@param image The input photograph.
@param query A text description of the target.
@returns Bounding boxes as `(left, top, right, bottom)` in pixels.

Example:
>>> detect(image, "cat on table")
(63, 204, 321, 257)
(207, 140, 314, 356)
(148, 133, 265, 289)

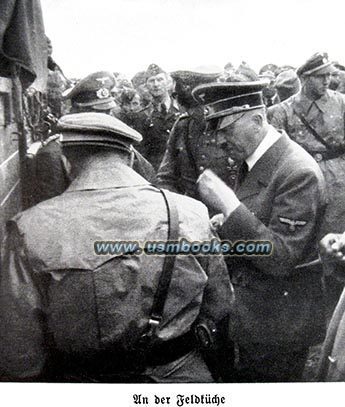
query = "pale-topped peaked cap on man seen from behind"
(58, 112, 142, 151)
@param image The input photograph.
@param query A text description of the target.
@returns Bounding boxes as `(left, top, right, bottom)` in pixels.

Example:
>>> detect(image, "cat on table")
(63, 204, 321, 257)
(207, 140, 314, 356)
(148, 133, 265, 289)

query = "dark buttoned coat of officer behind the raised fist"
(157, 108, 238, 199)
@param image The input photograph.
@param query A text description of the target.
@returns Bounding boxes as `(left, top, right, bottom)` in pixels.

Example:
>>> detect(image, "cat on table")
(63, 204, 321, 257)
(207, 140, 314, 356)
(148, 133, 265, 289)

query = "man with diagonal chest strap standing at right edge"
(268, 53, 345, 313)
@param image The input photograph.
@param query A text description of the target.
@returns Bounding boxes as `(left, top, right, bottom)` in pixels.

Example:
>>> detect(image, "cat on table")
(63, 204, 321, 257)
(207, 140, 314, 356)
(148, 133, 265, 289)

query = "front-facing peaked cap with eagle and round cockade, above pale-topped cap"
(62, 71, 116, 110)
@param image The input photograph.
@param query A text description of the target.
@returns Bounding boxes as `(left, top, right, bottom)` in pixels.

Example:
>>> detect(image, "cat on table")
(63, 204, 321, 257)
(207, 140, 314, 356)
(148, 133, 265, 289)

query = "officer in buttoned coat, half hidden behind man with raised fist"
(157, 71, 236, 198)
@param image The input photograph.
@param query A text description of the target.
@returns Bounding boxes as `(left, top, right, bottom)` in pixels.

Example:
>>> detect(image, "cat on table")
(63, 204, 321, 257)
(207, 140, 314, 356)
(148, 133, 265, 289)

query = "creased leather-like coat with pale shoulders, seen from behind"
(0, 162, 232, 378)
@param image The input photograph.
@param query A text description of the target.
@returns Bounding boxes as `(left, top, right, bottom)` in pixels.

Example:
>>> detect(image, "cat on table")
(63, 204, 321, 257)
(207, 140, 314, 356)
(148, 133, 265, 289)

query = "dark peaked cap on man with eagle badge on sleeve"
(193, 80, 267, 121)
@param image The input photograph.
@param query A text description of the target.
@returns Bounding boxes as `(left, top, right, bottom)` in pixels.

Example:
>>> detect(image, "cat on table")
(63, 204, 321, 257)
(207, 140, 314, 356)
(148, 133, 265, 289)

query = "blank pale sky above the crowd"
(41, 0, 345, 78)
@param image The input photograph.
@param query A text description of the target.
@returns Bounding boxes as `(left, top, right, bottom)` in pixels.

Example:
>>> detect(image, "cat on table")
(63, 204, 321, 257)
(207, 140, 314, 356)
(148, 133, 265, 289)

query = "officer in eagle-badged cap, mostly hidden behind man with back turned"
(35, 71, 155, 203)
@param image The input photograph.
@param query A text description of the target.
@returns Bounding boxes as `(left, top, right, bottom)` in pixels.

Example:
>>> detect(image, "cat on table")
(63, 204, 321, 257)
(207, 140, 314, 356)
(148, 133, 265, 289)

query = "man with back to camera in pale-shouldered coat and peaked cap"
(0, 113, 232, 382)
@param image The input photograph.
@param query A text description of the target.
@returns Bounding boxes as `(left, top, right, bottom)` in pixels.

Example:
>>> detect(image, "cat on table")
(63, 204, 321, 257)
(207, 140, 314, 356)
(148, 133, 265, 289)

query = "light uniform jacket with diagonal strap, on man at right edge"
(267, 90, 345, 235)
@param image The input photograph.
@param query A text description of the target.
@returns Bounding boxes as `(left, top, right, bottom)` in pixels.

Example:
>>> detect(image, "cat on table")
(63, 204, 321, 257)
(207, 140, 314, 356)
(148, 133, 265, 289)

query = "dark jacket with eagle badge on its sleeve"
(220, 129, 325, 346)
